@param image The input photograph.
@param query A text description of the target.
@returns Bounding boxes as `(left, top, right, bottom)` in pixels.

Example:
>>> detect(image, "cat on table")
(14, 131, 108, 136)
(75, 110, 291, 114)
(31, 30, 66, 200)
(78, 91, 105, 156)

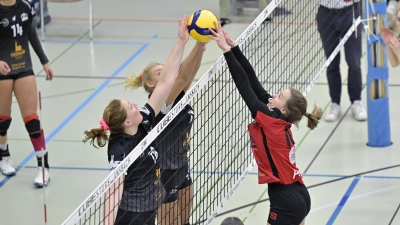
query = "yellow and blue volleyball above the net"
(187, 10, 218, 42)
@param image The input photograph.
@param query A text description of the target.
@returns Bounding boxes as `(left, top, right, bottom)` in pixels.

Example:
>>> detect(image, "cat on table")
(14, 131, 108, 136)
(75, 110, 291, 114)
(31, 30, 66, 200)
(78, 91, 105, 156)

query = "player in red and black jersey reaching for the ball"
(209, 23, 322, 225)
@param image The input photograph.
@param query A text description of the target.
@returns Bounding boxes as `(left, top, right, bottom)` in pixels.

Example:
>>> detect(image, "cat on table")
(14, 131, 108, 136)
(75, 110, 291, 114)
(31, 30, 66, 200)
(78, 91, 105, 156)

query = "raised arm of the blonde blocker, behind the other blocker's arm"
(166, 42, 205, 105)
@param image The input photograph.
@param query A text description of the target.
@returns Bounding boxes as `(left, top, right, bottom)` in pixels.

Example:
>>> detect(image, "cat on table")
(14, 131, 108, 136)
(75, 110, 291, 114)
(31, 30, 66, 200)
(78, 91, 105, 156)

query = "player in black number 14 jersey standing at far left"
(0, 0, 53, 187)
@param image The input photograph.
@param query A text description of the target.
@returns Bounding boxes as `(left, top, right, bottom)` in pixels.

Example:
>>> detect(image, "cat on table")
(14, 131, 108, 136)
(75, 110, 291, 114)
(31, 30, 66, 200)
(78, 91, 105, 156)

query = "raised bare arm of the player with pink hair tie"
(148, 14, 189, 115)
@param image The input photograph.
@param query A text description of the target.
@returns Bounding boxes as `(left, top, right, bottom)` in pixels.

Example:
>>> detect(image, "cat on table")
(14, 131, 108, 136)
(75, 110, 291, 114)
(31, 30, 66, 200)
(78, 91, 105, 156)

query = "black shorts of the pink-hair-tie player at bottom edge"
(114, 209, 156, 225)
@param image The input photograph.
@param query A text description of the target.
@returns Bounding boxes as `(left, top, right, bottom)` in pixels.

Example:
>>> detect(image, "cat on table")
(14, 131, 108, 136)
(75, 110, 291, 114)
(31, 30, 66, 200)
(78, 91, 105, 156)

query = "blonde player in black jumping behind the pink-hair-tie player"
(125, 42, 205, 225)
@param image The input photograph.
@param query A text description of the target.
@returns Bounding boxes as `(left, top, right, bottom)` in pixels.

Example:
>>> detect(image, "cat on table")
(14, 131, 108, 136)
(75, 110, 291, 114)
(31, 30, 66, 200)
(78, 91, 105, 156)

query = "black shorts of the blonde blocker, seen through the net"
(161, 163, 192, 203)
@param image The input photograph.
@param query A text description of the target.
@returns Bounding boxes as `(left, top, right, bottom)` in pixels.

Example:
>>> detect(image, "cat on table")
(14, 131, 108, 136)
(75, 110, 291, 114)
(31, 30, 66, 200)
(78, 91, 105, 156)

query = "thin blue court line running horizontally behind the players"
(12, 166, 400, 179)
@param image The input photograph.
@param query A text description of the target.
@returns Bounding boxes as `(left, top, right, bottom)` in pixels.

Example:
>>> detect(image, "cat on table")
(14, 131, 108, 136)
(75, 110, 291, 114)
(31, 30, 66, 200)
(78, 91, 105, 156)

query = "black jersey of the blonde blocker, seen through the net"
(153, 91, 194, 170)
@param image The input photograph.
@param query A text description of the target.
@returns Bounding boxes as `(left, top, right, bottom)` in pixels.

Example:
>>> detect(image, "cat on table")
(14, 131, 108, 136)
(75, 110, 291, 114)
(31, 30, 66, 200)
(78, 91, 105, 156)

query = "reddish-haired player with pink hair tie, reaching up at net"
(83, 15, 189, 225)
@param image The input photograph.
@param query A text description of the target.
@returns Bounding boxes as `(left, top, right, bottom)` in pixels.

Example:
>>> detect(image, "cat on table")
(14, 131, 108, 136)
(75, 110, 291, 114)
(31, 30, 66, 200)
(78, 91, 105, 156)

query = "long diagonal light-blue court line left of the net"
(0, 43, 149, 188)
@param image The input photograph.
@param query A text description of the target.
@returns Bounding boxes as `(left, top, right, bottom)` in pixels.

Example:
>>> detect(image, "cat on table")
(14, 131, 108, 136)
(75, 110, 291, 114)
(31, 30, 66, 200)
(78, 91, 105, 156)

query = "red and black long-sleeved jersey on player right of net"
(224, 46, 303, 184)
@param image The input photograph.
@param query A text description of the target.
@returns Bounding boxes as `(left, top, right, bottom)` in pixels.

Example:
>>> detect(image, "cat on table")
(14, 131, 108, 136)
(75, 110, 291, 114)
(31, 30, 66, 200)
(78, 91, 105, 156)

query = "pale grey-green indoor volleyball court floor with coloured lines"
(0, 0, 400, 225)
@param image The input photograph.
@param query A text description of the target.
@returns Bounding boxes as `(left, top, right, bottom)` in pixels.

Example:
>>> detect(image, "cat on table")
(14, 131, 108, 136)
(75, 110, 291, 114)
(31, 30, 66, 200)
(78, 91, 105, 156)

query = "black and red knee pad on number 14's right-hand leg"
(24, 113, 47, 157)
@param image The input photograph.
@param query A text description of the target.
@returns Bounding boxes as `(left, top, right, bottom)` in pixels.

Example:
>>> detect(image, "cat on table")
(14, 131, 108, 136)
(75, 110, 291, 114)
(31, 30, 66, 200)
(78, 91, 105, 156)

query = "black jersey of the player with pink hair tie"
(108, 104, 165, 212)
